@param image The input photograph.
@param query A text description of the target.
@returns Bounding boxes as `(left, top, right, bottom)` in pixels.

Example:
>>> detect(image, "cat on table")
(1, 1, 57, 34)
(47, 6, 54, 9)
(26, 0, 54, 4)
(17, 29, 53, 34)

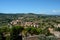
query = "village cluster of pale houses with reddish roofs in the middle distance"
(10, 20, 39, 28)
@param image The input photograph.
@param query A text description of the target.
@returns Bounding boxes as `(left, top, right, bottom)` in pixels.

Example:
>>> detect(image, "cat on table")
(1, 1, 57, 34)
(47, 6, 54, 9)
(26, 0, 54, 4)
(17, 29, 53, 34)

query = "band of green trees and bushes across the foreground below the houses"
(0, 26, 52, 40)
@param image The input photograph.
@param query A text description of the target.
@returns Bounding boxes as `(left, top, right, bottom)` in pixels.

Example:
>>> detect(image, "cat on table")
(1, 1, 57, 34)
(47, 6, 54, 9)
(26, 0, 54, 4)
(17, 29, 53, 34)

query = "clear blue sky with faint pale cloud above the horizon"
(0, 0, 60, 14)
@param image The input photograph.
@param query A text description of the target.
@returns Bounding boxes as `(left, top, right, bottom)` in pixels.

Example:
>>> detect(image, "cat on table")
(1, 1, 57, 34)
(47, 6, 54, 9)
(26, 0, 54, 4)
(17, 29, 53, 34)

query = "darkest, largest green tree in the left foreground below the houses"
(10, 26, 24, 40)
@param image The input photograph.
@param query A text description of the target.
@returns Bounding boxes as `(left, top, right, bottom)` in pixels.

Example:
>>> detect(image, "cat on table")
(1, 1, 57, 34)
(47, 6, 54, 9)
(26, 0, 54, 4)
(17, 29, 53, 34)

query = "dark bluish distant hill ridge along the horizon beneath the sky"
(0, 13, 60, 16)
